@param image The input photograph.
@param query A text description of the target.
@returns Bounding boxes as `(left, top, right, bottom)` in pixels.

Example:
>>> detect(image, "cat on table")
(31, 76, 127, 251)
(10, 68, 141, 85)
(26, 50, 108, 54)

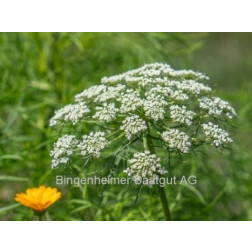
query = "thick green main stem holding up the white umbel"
(144, 124, 171, 221)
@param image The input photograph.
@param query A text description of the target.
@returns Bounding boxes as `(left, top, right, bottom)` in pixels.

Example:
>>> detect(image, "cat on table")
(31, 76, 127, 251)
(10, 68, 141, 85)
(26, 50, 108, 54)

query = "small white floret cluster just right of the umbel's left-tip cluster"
(93, 102, 119, 122)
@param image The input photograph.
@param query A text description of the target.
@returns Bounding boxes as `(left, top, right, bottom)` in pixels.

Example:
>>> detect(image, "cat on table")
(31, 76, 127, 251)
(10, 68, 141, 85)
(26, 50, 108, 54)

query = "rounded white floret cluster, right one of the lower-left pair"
(77, 132, 108, 158)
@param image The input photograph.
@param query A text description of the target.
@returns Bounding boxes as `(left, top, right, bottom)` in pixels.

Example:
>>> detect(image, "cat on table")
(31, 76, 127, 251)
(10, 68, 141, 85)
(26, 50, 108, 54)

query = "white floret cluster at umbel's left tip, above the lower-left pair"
(50, 102, 90, 126)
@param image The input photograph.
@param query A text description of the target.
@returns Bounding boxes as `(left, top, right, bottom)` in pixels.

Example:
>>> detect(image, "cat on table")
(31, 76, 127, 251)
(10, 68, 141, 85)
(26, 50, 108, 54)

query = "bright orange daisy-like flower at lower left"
(15, 186, 61, 213)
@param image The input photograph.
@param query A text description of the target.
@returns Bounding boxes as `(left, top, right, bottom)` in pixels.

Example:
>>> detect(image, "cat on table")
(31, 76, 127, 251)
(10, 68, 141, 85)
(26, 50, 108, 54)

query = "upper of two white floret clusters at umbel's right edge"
(199, 97, 237, 119)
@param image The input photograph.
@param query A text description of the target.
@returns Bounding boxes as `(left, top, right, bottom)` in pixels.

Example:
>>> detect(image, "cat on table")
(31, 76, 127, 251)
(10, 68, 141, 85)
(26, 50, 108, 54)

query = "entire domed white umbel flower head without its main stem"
(50, 63, 236, 173)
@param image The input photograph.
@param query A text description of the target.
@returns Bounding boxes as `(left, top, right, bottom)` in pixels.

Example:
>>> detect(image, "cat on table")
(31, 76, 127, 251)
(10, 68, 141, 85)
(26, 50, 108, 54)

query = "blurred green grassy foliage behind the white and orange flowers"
(0, 33, 252, 220)
